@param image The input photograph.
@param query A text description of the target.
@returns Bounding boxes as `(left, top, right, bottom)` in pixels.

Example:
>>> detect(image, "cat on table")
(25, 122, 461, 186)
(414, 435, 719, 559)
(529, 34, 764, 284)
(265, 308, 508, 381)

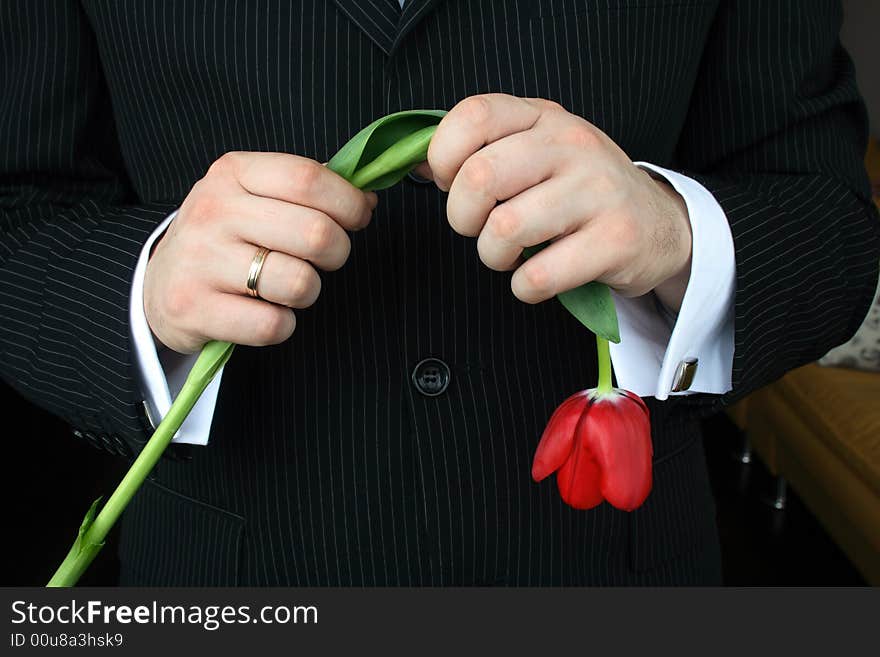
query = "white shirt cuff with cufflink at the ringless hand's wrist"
(611, 162, 736, 400)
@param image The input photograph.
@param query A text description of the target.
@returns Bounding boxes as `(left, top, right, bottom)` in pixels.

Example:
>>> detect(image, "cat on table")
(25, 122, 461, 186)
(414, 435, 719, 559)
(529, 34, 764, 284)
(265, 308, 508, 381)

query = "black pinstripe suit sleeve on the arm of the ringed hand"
(0, 0, 177, 455)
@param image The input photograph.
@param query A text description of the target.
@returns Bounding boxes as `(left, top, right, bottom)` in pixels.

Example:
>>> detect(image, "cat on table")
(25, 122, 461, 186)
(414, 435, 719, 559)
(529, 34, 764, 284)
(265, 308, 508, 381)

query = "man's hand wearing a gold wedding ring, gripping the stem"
(144, 152, 376, 353)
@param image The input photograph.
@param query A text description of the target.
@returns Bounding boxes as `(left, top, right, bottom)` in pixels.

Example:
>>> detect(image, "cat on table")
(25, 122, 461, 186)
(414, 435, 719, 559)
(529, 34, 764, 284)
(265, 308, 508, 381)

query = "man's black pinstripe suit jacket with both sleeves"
(0, 0, 878, 585)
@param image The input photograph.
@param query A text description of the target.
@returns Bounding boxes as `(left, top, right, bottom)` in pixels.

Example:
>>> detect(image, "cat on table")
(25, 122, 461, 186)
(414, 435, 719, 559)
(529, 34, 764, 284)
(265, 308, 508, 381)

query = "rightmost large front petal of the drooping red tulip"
(583, 393, 653, 511)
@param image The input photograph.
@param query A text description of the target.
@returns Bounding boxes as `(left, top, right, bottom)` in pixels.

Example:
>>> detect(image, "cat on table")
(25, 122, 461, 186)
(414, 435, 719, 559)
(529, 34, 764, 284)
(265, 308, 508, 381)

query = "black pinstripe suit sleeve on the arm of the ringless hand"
(669, 0, 880, 409)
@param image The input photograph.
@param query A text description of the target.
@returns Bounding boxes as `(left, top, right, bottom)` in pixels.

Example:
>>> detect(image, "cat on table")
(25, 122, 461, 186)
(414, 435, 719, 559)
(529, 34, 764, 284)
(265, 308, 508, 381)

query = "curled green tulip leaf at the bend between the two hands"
(327, 110, 446, 183)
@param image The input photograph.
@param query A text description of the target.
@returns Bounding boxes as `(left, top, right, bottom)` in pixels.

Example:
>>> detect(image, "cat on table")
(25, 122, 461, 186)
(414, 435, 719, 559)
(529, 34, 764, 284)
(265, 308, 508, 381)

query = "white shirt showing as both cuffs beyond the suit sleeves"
(130, 162, 736, 445)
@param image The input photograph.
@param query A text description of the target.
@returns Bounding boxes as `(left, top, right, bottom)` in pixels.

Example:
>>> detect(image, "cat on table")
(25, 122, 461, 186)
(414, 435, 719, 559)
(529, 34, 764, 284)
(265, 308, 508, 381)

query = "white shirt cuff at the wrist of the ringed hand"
(129, 212, 223, 445)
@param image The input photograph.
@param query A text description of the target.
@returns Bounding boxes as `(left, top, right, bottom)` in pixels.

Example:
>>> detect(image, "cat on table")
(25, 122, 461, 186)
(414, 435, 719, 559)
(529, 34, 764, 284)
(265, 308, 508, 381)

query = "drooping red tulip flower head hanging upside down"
(532, 388, 653, 511)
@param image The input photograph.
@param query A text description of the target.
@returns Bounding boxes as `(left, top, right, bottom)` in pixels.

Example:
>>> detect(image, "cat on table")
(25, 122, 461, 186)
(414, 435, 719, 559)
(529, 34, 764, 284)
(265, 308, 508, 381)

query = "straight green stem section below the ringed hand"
(47, 341, 235, 587)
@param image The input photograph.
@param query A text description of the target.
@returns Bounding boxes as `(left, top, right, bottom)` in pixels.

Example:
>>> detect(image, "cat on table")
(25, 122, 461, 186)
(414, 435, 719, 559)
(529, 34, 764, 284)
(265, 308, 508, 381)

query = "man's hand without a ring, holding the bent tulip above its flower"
(419, 94, 691, 310)
